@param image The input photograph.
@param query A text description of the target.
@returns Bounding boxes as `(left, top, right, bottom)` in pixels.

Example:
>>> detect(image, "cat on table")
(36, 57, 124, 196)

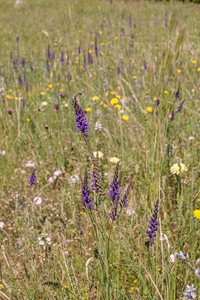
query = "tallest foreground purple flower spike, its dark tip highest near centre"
(72, 97, 89, 136)
